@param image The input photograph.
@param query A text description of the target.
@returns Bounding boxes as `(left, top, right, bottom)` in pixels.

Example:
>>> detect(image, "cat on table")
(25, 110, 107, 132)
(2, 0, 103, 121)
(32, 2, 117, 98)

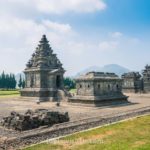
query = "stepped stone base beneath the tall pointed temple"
(20, 88, 57, 101)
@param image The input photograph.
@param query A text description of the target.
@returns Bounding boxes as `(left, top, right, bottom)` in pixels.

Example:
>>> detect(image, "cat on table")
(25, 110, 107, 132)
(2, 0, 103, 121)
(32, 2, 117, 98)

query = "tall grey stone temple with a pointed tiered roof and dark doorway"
(21, 35, 65, 101)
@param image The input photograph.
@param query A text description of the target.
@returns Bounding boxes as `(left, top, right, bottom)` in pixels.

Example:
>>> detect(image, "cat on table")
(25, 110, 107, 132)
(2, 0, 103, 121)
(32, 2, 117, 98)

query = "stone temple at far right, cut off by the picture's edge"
(143, 65, 150, 93)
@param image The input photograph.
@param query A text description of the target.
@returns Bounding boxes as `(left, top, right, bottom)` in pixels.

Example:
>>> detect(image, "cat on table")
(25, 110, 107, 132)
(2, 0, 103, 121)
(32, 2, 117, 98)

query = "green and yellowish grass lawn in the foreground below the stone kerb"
(24, 116, 150, 150)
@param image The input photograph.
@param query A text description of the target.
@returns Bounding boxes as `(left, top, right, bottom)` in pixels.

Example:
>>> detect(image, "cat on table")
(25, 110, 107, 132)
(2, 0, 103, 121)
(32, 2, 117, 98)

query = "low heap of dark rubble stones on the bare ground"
(0, 109, 69, 131)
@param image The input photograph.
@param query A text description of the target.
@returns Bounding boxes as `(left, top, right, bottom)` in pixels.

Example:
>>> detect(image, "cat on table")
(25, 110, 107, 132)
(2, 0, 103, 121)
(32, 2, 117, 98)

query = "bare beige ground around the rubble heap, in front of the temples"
(0, 94, 150, 149)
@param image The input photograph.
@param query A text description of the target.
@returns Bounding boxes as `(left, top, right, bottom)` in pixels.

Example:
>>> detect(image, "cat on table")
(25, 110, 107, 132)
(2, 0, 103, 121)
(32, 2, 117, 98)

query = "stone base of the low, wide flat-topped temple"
(69, 95, 128, 106)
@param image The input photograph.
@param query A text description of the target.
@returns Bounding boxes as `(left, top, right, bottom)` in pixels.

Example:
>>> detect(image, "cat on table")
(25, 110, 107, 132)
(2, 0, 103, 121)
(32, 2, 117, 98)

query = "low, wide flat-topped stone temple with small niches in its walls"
(69, 72, 128, 104)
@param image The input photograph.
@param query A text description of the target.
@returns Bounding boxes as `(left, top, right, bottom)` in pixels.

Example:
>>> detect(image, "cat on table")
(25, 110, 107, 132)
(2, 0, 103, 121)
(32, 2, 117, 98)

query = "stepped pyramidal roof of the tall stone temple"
(26, 35, 63, 69)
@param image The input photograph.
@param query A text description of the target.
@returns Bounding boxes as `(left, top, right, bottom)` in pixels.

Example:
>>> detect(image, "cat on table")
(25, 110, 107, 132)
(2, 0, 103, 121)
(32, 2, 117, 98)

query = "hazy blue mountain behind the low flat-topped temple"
(75, 64, 130, 77)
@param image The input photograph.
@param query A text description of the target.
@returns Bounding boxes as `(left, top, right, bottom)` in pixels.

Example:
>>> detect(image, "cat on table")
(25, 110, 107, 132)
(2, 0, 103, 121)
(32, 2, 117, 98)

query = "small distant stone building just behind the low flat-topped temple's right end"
(122, 72, 143, 93)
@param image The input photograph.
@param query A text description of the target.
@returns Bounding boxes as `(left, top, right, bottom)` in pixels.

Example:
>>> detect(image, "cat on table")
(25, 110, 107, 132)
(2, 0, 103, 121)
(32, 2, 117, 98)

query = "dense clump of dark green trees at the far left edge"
(0, 71, 17, 89)
